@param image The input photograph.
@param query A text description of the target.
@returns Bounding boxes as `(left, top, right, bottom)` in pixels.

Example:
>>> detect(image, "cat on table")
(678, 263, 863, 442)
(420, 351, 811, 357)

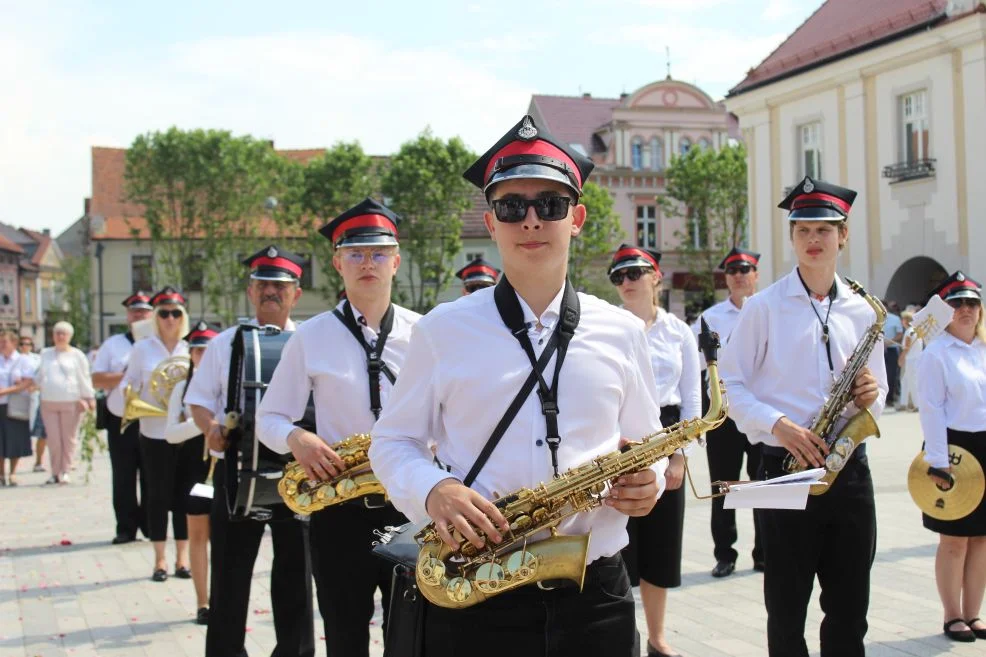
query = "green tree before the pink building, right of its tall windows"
(658, 144, 747, 310)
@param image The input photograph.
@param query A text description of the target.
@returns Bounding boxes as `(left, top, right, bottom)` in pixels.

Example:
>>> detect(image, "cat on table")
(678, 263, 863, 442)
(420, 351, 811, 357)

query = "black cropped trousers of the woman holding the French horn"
(140, 435, 201, 541)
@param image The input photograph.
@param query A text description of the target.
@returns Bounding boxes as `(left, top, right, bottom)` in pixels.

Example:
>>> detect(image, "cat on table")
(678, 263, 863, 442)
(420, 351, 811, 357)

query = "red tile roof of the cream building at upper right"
(729, 0, 947, 96)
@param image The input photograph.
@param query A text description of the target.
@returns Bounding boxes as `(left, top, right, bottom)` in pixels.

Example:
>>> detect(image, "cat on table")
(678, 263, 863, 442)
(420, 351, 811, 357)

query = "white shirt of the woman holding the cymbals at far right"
(917, 333, 986, 468)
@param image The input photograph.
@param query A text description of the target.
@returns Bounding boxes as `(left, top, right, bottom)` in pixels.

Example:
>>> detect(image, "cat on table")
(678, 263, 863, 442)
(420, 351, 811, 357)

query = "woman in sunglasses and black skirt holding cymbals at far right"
(917, 271, 986, 641)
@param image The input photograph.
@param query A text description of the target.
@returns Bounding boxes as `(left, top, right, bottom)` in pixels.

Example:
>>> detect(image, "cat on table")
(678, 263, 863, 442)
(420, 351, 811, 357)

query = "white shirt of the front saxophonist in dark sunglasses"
(370, 287, 667, 562)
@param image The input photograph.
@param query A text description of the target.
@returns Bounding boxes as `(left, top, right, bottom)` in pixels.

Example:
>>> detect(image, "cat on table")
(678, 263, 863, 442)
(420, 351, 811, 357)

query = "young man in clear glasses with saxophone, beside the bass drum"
(257, 198, 420, 657)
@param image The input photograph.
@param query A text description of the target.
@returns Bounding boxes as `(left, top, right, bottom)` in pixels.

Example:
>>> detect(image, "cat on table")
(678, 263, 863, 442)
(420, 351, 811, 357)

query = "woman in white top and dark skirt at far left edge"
(0, 330, 34, 486)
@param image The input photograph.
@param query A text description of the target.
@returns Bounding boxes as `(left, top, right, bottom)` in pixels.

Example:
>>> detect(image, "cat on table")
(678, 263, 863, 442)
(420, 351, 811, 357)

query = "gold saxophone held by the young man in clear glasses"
(277, 433, 387, 516)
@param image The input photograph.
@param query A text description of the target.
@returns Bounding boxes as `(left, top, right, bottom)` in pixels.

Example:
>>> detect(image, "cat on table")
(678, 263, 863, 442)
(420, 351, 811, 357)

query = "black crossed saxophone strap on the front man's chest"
(462, 276, 581, 486)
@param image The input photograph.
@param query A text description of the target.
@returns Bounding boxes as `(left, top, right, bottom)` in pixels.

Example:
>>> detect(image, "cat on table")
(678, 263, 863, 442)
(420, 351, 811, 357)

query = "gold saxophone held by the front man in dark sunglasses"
(414, 320, 726, 609)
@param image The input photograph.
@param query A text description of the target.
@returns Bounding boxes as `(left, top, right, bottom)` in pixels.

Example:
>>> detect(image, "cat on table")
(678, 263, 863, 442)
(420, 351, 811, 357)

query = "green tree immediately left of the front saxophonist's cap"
(381, 129, 476, 312)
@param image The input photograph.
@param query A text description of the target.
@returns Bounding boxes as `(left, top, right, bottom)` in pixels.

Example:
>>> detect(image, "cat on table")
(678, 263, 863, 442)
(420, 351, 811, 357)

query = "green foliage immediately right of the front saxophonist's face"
(568, 182, 625, 301)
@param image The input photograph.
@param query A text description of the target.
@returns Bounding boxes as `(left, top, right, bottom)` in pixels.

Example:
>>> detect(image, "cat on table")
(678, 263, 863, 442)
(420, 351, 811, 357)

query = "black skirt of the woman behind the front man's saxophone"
(623, 406, 685, 589)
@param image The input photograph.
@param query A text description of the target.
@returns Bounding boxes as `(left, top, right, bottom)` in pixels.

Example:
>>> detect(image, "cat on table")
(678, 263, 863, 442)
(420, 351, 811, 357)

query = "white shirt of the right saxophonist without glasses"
(720, 268, 887, 446)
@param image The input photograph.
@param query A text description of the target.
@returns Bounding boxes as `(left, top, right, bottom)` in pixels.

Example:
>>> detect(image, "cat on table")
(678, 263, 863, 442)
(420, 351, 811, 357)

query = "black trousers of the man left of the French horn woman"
(106, 411, 150, 537)
